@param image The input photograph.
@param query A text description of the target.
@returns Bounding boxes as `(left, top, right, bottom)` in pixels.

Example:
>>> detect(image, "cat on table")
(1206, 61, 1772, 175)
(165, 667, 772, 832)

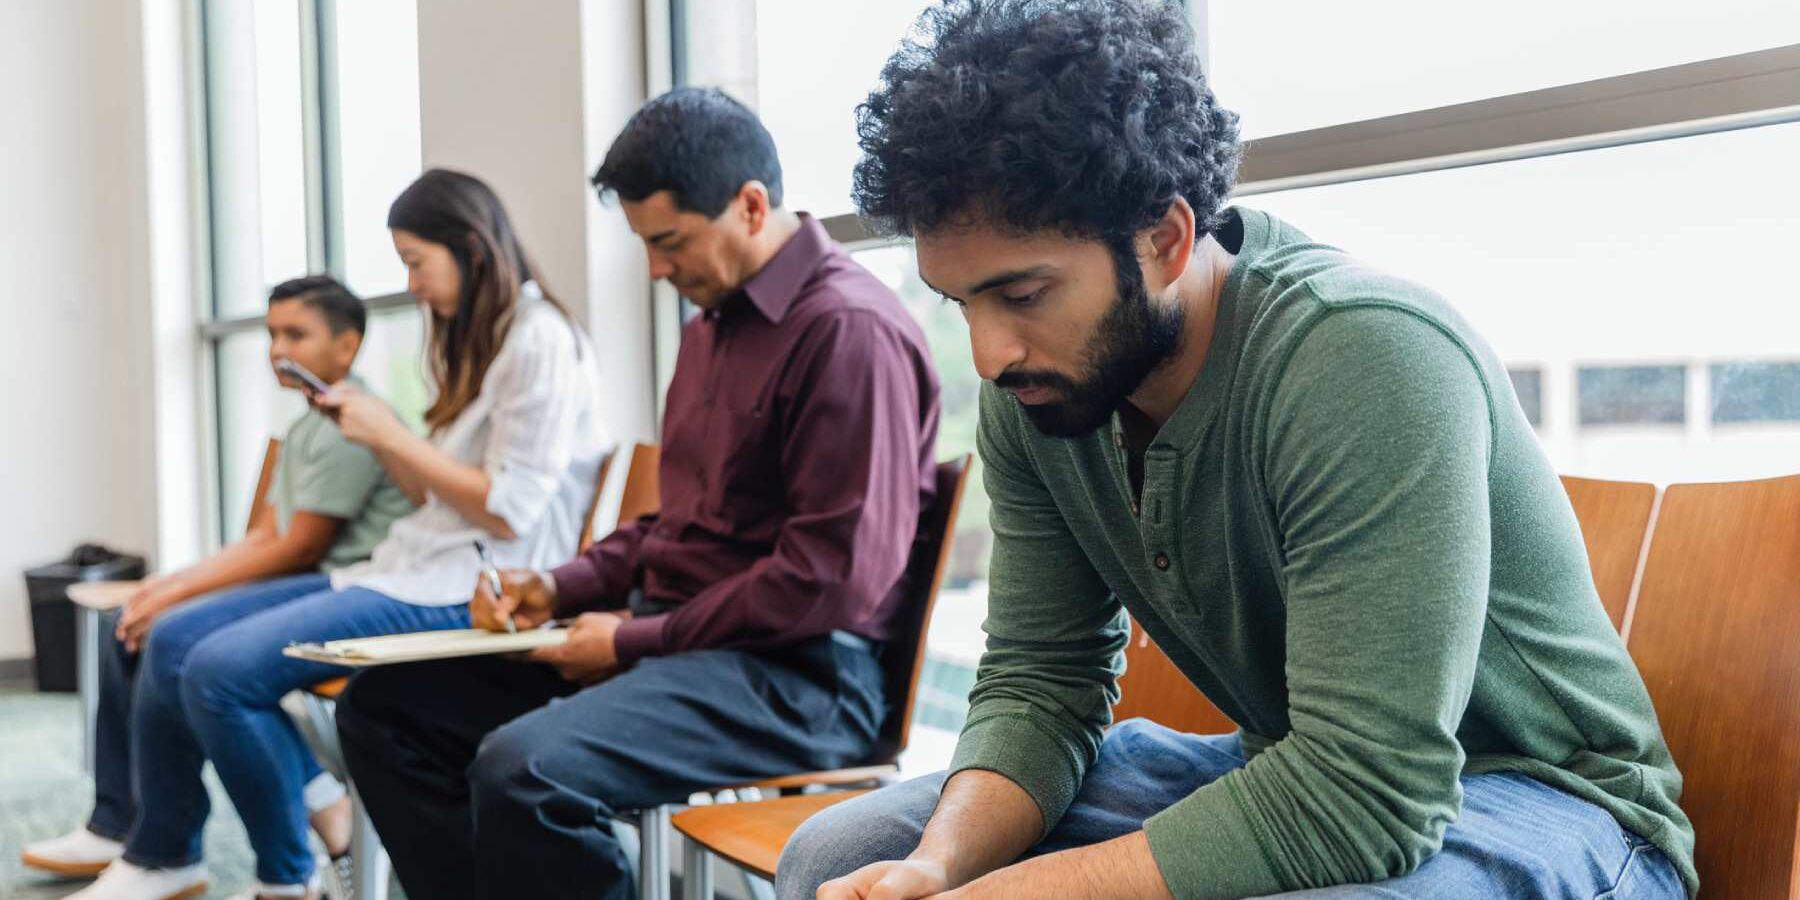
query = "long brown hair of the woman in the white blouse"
(387, 169, 574, 434)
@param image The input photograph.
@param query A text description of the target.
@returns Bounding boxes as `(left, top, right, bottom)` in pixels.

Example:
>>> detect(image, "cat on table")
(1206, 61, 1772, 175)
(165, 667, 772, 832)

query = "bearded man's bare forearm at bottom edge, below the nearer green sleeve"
(954, 828, 1174, 900)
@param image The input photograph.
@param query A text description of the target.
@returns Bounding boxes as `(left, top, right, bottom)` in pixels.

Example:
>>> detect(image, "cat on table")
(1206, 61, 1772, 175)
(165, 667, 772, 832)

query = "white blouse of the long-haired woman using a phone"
(331, 281, 607, 607)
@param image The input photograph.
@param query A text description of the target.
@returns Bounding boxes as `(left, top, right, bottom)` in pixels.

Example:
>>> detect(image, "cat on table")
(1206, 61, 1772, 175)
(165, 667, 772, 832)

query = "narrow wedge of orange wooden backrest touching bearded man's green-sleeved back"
(1562, 475, 1656, 632)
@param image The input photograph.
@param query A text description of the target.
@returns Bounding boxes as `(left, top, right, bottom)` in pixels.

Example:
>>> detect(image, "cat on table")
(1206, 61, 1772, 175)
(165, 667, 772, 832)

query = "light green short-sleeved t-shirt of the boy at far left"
(270, 378, 414, 572)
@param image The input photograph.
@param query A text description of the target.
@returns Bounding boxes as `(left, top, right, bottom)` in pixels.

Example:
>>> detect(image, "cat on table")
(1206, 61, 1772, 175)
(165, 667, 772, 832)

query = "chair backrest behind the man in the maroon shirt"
(869, 454, 970, 765)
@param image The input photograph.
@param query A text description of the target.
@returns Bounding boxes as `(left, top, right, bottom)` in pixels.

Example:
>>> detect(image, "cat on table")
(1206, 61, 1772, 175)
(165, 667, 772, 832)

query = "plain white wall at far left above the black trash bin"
(0, 0, 157, 659)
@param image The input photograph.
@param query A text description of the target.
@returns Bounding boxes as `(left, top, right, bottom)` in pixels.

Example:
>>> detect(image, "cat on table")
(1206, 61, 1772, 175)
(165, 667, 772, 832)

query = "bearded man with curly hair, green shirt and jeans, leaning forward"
(778, 0, 1697, 900)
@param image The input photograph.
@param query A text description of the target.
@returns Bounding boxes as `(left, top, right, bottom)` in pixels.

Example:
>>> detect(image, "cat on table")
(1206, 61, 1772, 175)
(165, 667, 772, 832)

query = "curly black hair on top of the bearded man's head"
(853, 0, 1238, 247)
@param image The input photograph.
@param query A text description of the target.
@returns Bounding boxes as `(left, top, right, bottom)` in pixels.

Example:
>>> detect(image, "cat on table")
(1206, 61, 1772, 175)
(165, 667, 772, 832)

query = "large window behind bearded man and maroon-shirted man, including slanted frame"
(670, 0, 1800, 748)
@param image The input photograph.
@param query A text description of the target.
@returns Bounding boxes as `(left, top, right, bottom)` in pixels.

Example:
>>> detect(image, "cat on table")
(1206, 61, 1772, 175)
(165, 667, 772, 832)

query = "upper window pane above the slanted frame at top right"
(1204, 0, 1800, 137)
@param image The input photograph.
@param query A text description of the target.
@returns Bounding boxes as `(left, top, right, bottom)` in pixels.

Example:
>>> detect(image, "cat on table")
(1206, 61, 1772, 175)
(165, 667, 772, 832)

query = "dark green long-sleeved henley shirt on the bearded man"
(952, 209, 1696, 898)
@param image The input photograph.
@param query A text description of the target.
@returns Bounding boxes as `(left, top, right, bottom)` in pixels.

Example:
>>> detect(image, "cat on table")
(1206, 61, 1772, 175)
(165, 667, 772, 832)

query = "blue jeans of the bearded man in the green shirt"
(776, 718, 1687, 900)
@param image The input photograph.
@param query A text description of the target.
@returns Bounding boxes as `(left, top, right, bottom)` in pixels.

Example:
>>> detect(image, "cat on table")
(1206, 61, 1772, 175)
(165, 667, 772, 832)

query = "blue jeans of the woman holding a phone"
(124, 574, 468, 884)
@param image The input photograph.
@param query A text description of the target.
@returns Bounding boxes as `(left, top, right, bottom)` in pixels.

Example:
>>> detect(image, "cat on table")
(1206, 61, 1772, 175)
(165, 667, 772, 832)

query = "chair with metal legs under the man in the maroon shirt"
(637, 454, 970, 900)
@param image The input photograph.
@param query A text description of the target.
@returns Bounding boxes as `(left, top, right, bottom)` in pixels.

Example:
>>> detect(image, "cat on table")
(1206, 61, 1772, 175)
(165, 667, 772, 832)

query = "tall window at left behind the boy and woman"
(196, 0, 427, 540)
